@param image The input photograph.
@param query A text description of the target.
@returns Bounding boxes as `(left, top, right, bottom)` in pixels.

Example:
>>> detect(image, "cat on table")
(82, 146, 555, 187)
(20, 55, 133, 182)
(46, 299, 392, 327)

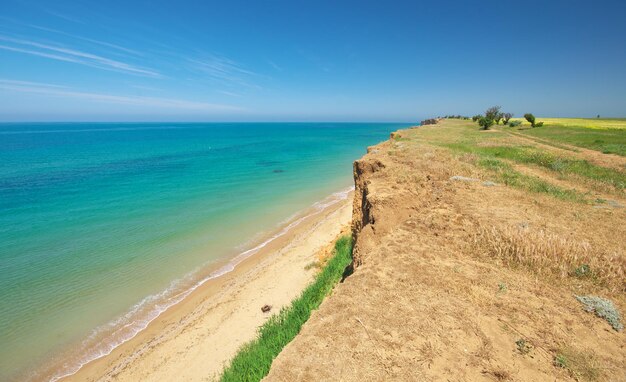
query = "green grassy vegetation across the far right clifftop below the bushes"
(410, 117, 626, 198)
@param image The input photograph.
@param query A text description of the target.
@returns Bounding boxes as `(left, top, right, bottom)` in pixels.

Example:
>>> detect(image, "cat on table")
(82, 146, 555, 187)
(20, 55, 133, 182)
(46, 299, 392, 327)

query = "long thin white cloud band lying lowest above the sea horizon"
(0, 79, 242, 112)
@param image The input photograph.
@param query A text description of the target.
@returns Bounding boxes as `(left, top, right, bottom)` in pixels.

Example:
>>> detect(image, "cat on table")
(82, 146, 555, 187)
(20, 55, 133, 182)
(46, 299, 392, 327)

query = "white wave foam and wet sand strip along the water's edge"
(45, 187, 354, 382)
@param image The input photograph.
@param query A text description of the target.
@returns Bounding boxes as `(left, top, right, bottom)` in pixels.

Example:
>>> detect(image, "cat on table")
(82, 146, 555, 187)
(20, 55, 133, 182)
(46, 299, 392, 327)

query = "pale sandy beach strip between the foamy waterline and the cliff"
(56, 192, 353, 381)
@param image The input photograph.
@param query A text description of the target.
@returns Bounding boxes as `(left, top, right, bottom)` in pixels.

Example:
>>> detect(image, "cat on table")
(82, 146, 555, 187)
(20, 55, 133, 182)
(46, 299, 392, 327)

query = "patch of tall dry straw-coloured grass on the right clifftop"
(473, 227, 626, 292)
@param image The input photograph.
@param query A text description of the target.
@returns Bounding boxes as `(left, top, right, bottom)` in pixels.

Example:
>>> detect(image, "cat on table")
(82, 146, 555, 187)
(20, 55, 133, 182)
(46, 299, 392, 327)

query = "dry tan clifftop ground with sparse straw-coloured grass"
(266, 124, 626, 381)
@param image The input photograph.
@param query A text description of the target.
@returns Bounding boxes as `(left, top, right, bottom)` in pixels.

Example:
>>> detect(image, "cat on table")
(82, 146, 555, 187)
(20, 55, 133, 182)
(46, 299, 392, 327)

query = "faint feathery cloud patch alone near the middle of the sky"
(187, 55, 259, 88)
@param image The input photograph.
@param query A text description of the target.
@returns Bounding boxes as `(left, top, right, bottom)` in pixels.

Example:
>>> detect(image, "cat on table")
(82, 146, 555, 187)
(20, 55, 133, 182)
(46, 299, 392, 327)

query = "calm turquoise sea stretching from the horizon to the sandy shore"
(0, 123, 406, 380)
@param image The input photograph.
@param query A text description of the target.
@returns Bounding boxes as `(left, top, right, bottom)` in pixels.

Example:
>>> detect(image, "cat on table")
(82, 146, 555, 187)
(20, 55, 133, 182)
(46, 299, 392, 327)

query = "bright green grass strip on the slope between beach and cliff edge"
(221, 236, 352, 382)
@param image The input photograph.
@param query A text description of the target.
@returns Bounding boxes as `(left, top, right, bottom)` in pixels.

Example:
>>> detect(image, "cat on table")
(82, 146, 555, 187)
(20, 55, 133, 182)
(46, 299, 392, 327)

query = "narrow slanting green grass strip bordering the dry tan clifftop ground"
(477, 158, 586, 203)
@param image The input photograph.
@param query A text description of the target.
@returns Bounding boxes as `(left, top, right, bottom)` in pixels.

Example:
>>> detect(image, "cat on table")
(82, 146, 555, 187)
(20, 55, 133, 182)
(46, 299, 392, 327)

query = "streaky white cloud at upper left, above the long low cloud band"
(0, 35, 162, 78)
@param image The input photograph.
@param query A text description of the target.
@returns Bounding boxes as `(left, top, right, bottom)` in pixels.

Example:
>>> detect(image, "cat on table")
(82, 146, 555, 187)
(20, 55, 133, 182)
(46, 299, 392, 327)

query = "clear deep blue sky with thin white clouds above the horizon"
(0, 0, 626, 122)
